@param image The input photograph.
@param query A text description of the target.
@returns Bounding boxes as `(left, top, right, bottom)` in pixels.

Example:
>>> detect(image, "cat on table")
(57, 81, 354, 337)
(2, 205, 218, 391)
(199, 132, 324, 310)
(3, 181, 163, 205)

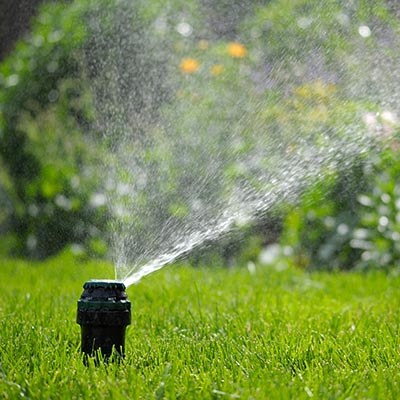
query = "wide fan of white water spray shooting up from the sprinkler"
(82, 0, 400, 287)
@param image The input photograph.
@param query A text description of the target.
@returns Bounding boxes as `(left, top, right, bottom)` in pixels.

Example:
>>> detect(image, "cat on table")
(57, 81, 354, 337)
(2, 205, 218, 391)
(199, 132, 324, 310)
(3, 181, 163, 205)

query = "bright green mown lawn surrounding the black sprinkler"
(0, 257, 400, 399)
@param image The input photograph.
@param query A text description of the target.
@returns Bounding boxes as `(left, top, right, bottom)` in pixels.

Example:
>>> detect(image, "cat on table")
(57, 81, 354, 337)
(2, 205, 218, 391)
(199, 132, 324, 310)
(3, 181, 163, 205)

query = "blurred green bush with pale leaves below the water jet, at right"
(280, 132, 400, 270)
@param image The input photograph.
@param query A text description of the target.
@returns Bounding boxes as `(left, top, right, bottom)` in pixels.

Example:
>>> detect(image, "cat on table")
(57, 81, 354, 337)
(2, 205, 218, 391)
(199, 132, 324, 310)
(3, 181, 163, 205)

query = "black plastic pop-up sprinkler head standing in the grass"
(76, 280, 131, 360)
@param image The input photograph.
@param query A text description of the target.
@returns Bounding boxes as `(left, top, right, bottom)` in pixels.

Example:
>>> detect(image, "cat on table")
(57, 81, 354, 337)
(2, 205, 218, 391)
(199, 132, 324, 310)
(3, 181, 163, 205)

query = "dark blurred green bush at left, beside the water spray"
(0, 0, 178, 258)
